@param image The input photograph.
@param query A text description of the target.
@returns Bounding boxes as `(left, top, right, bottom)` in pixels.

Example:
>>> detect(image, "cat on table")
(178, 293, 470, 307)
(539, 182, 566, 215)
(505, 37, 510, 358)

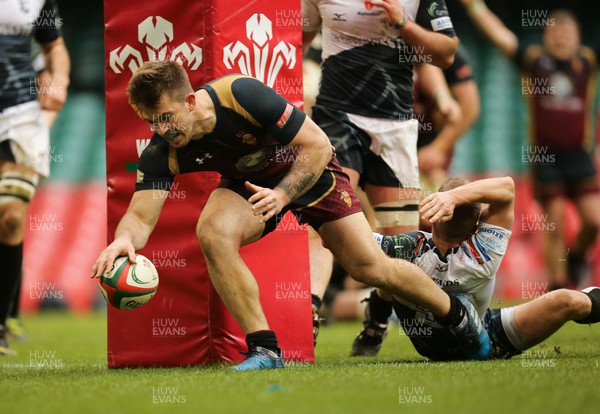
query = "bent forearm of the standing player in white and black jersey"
(399, 20, 458, 68)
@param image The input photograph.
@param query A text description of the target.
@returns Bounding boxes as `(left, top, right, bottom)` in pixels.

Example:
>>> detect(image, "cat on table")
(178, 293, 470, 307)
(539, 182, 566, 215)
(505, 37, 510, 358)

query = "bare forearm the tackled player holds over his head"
(450, 177, 515, 206)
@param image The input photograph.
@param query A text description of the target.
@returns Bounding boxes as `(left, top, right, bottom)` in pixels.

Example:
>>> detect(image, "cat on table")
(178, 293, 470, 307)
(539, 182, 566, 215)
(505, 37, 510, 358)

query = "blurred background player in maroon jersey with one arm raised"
(461, 0, 600, 290)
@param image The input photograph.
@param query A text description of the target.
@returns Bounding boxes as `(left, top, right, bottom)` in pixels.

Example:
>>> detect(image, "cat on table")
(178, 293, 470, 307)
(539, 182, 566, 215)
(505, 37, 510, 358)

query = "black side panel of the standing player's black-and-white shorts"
(312, 105, 402, 188)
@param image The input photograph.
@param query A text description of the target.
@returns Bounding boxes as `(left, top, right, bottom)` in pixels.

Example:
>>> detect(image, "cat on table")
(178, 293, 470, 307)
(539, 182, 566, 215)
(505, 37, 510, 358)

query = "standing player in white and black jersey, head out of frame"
(302, 0, 458, 342)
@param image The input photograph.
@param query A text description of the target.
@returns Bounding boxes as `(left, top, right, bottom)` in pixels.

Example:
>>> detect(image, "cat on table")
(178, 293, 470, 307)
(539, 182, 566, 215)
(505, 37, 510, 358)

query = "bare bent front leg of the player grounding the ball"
(196, 188, 269, 334)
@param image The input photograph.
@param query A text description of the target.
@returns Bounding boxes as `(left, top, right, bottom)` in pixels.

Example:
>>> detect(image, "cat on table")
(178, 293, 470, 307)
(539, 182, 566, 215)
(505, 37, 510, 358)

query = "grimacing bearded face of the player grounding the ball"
(144, 96, 193, 148)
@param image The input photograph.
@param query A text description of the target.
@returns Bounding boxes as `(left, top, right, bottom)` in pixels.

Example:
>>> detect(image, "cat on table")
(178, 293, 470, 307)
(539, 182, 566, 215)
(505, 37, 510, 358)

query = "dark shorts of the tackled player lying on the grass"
(394, 301, 522, 361)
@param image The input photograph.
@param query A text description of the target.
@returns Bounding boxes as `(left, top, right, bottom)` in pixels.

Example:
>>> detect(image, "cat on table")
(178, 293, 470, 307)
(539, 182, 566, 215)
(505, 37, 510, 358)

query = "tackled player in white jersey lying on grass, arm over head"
(352, 177, 600, 361)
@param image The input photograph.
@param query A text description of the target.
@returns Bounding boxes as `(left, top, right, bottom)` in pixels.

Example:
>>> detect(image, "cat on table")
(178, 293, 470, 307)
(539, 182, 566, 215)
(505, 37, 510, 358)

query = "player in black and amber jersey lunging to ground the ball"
(92, 62, 491, 370)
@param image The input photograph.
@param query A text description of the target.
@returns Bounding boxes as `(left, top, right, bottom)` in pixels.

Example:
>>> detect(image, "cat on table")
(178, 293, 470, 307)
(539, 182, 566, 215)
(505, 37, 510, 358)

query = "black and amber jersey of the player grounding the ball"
(136, 75, 306, 191)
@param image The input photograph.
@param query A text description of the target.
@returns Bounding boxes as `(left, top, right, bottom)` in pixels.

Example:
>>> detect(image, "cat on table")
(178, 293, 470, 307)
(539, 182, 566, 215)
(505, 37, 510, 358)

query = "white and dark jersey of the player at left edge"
(0, 0, 62, 111)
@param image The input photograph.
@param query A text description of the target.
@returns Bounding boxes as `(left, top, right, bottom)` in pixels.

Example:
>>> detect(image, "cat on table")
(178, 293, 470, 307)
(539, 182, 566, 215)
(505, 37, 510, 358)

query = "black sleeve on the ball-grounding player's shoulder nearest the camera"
(231, 77, 306, 145)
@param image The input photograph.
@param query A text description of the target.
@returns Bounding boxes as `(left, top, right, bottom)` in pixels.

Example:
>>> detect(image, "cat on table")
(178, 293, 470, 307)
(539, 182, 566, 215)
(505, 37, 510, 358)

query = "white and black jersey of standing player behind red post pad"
(302, 0, 455, 119)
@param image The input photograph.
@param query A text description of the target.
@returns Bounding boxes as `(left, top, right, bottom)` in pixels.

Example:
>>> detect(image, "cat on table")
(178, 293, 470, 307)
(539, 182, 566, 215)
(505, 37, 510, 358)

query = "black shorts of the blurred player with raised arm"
(525, 148, 598, 203)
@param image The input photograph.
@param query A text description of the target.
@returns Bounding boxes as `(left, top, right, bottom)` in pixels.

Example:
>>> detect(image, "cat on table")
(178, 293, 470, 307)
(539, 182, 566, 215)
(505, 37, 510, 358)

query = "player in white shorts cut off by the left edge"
(0, 0, 70, 355)
